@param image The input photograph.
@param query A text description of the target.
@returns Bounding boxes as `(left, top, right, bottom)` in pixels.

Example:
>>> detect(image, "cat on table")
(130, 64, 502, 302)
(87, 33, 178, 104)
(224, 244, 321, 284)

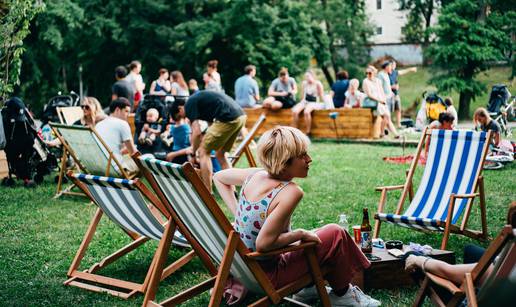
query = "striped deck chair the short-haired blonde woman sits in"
(135, 157, 330, 306)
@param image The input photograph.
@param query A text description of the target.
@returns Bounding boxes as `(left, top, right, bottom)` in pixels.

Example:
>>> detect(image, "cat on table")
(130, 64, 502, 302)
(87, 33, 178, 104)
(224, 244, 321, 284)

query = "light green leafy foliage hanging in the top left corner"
(0, 0, 44, 101)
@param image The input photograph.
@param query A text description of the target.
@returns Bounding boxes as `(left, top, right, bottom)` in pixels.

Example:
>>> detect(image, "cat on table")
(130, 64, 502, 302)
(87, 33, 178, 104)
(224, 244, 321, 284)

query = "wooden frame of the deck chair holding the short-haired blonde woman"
(133, 153, 330, 307)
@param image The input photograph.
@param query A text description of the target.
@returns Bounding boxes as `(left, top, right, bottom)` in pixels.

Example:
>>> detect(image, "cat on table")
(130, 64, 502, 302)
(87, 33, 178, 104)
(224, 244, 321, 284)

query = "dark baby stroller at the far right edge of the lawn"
(487, 84, 515, 137)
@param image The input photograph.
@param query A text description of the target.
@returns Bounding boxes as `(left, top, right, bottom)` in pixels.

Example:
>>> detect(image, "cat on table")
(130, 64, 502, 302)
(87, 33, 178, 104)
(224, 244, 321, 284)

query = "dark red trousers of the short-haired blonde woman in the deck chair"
(261, 224, 371, 290)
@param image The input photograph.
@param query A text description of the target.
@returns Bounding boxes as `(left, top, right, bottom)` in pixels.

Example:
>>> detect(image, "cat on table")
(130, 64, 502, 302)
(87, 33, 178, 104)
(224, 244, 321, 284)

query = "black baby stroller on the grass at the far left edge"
(1, 97, 57, 187)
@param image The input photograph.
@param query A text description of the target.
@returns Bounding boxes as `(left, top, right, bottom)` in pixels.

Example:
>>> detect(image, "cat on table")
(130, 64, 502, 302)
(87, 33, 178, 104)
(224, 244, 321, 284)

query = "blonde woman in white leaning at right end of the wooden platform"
(362, 66, 399, 138)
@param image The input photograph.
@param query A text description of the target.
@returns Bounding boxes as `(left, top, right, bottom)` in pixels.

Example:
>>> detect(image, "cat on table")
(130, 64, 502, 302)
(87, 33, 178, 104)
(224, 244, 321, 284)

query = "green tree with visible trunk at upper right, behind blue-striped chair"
(426, 0, 514, 119)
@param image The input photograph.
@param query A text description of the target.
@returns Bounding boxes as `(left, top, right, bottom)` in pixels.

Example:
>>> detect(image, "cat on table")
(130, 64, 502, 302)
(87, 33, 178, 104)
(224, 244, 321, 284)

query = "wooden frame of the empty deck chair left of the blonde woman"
(64, 171, 204, 299)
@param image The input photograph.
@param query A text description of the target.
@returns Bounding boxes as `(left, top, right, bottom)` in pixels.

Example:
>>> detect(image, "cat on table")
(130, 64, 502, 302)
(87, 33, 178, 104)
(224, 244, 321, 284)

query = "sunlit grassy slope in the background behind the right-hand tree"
(399, 67, 516, 116)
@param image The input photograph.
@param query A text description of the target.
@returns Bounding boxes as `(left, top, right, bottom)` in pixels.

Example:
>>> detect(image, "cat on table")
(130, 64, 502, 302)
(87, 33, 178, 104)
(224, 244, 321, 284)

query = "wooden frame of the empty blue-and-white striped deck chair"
(374, 128, 492, 250)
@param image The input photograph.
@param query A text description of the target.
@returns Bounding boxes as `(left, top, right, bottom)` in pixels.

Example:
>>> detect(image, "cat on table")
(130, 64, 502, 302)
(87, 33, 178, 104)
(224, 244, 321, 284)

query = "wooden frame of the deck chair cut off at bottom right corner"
(412, 225, 515, 307)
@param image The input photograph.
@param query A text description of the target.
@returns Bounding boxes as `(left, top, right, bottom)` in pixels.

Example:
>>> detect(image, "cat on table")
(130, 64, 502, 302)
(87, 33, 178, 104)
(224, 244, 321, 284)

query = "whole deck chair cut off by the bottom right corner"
(413, 225, 516, 307)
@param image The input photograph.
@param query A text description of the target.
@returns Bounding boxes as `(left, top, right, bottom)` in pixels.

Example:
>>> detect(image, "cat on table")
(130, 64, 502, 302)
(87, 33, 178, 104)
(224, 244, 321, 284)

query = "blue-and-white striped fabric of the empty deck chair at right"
(376, 130, 487, 231)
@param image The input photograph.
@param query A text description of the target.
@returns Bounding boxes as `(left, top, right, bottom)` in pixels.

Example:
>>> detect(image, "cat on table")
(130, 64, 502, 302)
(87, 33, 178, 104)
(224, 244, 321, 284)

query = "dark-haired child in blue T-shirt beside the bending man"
(166, 99, 193, 164)
